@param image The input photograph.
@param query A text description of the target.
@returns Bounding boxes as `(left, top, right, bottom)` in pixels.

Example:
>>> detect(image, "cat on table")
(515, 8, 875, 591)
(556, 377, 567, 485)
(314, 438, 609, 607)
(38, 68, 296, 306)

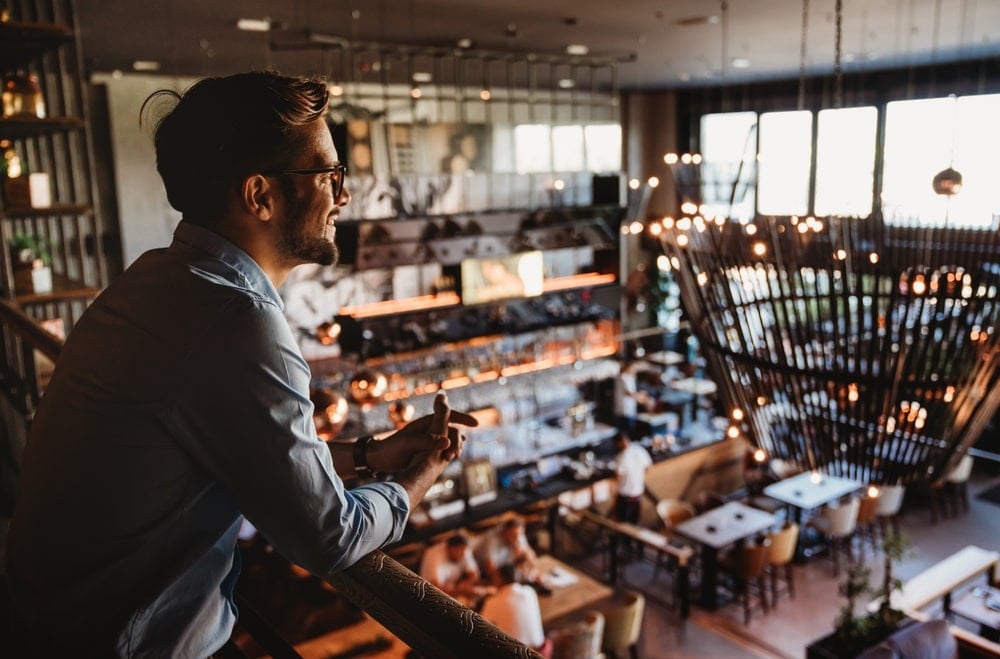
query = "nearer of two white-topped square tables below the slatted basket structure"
(674, 501, 779, 610)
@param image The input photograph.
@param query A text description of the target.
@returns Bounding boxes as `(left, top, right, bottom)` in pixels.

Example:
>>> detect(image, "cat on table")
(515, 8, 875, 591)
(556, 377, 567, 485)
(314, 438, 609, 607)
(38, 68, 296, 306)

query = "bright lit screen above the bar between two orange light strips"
(461, 251, 544, 304)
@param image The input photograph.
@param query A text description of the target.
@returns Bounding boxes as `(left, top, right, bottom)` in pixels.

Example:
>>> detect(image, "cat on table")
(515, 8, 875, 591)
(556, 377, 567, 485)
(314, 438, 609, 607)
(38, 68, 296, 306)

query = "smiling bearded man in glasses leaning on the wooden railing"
(7, 72, 475, 657)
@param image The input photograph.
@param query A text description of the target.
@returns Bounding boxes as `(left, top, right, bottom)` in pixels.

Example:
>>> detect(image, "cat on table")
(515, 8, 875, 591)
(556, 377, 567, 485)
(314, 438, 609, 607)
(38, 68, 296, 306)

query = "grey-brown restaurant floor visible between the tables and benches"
(297, 470, 1000, 659)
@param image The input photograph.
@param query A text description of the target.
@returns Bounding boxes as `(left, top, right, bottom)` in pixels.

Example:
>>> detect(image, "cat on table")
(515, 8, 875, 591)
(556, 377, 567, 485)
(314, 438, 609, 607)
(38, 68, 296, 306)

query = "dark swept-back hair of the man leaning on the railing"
(141, 71, 329, 223)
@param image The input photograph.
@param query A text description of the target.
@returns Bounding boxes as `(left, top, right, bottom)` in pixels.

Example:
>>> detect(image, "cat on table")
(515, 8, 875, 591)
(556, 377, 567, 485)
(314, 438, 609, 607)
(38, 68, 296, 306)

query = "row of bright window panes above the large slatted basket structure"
(700, 94, 1000, 228)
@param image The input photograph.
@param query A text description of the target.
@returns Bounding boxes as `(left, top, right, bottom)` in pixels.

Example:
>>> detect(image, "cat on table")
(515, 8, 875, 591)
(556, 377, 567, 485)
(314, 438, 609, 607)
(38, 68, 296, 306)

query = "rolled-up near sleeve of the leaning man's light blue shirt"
(169, 296, 409, 574)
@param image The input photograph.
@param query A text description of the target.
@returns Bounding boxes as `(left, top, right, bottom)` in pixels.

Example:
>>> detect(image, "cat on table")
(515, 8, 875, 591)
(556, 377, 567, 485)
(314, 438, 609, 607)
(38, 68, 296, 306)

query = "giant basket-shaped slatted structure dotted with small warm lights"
(655, 206, 1000, 484)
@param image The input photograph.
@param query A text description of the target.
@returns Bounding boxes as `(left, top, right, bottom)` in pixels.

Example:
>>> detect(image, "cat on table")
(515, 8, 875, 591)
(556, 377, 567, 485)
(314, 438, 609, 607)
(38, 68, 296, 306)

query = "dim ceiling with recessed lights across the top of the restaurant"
(77, 0, 1000, 89)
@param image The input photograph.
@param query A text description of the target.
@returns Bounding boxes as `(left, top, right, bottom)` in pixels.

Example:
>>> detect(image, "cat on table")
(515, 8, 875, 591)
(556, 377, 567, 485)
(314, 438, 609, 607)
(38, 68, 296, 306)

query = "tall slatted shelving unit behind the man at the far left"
(0, 0, 107, 332)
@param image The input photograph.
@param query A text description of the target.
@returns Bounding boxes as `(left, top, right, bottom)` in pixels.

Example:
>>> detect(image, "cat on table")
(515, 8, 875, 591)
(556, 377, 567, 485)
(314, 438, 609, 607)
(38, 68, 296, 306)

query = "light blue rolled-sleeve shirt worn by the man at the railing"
(8, 222, 409, 657)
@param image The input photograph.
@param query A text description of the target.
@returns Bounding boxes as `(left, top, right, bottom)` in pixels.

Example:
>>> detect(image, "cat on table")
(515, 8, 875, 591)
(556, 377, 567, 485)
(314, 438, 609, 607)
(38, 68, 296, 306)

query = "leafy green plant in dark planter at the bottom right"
(806, 534, 910, 659)
